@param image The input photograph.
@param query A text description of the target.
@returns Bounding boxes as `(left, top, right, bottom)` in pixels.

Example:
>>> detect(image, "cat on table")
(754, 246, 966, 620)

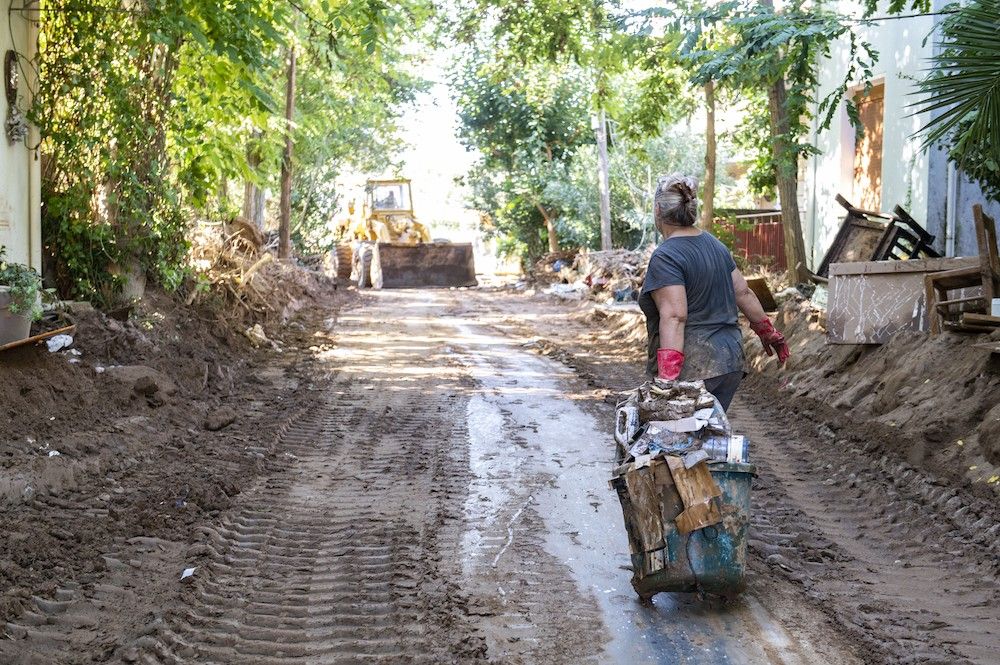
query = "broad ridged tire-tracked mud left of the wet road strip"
(125, 304, 485, 665)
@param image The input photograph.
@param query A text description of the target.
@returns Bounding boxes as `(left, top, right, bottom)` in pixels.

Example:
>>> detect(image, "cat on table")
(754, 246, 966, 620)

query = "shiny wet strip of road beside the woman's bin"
(454, 321, 820, 664)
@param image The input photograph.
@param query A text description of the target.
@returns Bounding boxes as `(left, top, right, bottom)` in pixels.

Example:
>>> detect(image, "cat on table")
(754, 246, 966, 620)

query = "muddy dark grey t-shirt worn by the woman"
(639, 231, 743, 380)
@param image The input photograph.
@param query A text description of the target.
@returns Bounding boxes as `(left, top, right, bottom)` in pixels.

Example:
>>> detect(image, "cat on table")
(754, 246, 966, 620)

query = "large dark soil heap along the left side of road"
(0, 271, 349, 624)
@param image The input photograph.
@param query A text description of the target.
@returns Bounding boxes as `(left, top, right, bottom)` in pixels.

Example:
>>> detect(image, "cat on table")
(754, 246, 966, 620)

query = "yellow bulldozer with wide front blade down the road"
(336, 178, 477, 289)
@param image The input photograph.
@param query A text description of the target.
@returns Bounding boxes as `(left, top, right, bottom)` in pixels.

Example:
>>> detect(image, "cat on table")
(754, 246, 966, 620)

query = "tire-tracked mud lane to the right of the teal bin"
(731, 398, 1000, 664)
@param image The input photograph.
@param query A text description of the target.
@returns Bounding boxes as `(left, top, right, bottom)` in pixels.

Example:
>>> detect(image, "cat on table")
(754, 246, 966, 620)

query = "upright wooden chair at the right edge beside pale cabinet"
(924, 204, 1000, 335)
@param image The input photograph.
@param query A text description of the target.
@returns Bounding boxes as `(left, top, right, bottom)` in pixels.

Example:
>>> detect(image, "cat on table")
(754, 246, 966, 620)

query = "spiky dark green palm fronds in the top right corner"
(915, 0, 1000, 200)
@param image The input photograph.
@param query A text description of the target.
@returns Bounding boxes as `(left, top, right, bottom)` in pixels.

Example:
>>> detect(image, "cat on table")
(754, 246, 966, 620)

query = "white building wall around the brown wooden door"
(803, 1, 934, 268)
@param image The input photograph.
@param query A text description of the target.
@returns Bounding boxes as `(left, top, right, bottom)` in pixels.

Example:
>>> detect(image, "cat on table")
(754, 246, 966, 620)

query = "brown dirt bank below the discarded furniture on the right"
(747, 303, 1000, 489)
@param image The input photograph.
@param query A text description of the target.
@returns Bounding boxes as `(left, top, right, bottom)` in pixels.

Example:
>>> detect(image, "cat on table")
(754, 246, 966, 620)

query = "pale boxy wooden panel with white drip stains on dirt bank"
(827, 257, 979, 344)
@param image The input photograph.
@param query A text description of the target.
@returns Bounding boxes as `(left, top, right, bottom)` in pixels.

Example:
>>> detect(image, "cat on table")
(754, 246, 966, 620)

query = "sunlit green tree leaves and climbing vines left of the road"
(30, 0, 432, 304)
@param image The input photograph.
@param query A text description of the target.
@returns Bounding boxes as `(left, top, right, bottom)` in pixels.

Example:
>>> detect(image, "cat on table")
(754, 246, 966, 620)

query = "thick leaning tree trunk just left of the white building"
(767, 78, 809, 282)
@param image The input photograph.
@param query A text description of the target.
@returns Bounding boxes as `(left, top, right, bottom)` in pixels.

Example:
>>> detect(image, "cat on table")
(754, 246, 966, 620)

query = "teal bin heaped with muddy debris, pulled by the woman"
(611, 380, 754, 599)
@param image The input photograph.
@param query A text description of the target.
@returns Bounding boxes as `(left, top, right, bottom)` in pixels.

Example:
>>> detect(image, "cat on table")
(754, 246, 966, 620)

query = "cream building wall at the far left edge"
(0, 6, 42, 270)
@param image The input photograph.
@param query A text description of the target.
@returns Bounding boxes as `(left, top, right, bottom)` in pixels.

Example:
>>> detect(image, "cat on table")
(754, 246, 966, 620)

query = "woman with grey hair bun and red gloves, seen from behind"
(639, 174, 789, 409)
